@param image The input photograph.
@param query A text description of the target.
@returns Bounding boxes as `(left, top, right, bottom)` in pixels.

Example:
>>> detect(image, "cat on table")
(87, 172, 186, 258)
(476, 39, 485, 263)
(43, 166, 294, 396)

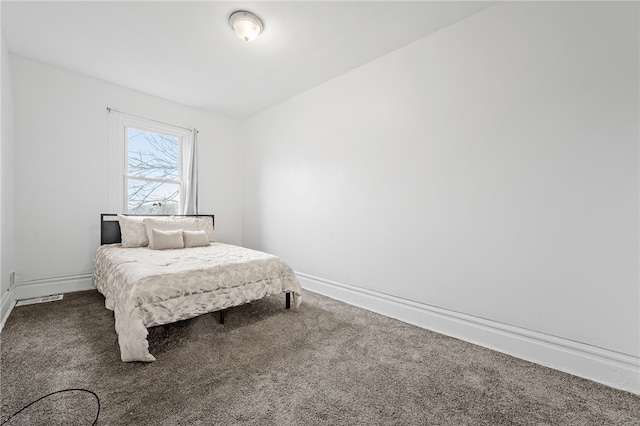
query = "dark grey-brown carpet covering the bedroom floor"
(0, 291, 640, 425)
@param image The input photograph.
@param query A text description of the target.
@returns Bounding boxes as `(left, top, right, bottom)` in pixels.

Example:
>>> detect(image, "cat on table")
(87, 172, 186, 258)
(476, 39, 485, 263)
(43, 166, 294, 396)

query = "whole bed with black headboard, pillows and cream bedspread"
(94, 214, 301, 362)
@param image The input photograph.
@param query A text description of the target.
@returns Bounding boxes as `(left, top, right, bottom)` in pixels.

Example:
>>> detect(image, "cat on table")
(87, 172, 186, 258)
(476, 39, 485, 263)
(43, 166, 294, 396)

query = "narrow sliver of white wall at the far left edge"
(0, 29, 15, 329)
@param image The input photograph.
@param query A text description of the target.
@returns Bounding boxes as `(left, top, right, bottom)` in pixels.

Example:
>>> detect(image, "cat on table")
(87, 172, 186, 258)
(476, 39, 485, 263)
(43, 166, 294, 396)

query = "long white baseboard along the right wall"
(296, 272, 640, 395)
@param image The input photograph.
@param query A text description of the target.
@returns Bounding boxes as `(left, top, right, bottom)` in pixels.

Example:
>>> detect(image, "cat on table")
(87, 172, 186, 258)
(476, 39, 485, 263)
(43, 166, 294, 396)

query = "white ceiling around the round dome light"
(1, 0, 495, 119)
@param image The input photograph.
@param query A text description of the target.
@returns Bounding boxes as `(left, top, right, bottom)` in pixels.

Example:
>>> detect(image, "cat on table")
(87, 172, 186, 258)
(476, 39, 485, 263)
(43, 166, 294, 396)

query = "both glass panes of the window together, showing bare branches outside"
(127, 125, 180, 215)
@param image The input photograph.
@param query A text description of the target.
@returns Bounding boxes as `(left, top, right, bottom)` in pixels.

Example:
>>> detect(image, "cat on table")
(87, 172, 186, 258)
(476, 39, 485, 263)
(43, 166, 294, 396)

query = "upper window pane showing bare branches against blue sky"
(128, 129, 180, 179)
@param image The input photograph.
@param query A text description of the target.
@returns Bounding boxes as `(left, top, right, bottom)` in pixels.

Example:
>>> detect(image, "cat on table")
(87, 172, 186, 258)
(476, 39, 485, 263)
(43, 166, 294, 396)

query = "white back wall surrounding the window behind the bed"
(11, 55, 242, 294)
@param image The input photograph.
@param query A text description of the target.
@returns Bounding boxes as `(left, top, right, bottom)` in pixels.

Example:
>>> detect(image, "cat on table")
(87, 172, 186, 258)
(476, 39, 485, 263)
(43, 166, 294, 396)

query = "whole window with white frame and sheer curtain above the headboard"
(109, 110, 197, 215)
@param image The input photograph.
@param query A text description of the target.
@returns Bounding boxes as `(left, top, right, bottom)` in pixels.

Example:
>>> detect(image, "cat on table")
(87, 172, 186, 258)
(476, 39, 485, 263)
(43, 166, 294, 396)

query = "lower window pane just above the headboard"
(127, 179, 180, 214)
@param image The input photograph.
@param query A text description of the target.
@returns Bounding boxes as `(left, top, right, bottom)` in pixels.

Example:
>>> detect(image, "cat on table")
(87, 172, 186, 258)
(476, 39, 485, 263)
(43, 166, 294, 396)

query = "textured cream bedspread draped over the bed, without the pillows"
(94, 242, 301, 362)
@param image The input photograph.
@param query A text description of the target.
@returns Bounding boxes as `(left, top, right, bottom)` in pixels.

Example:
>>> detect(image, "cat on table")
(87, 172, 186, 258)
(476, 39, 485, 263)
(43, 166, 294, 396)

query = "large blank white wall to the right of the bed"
(243, 2, 640, 392)
